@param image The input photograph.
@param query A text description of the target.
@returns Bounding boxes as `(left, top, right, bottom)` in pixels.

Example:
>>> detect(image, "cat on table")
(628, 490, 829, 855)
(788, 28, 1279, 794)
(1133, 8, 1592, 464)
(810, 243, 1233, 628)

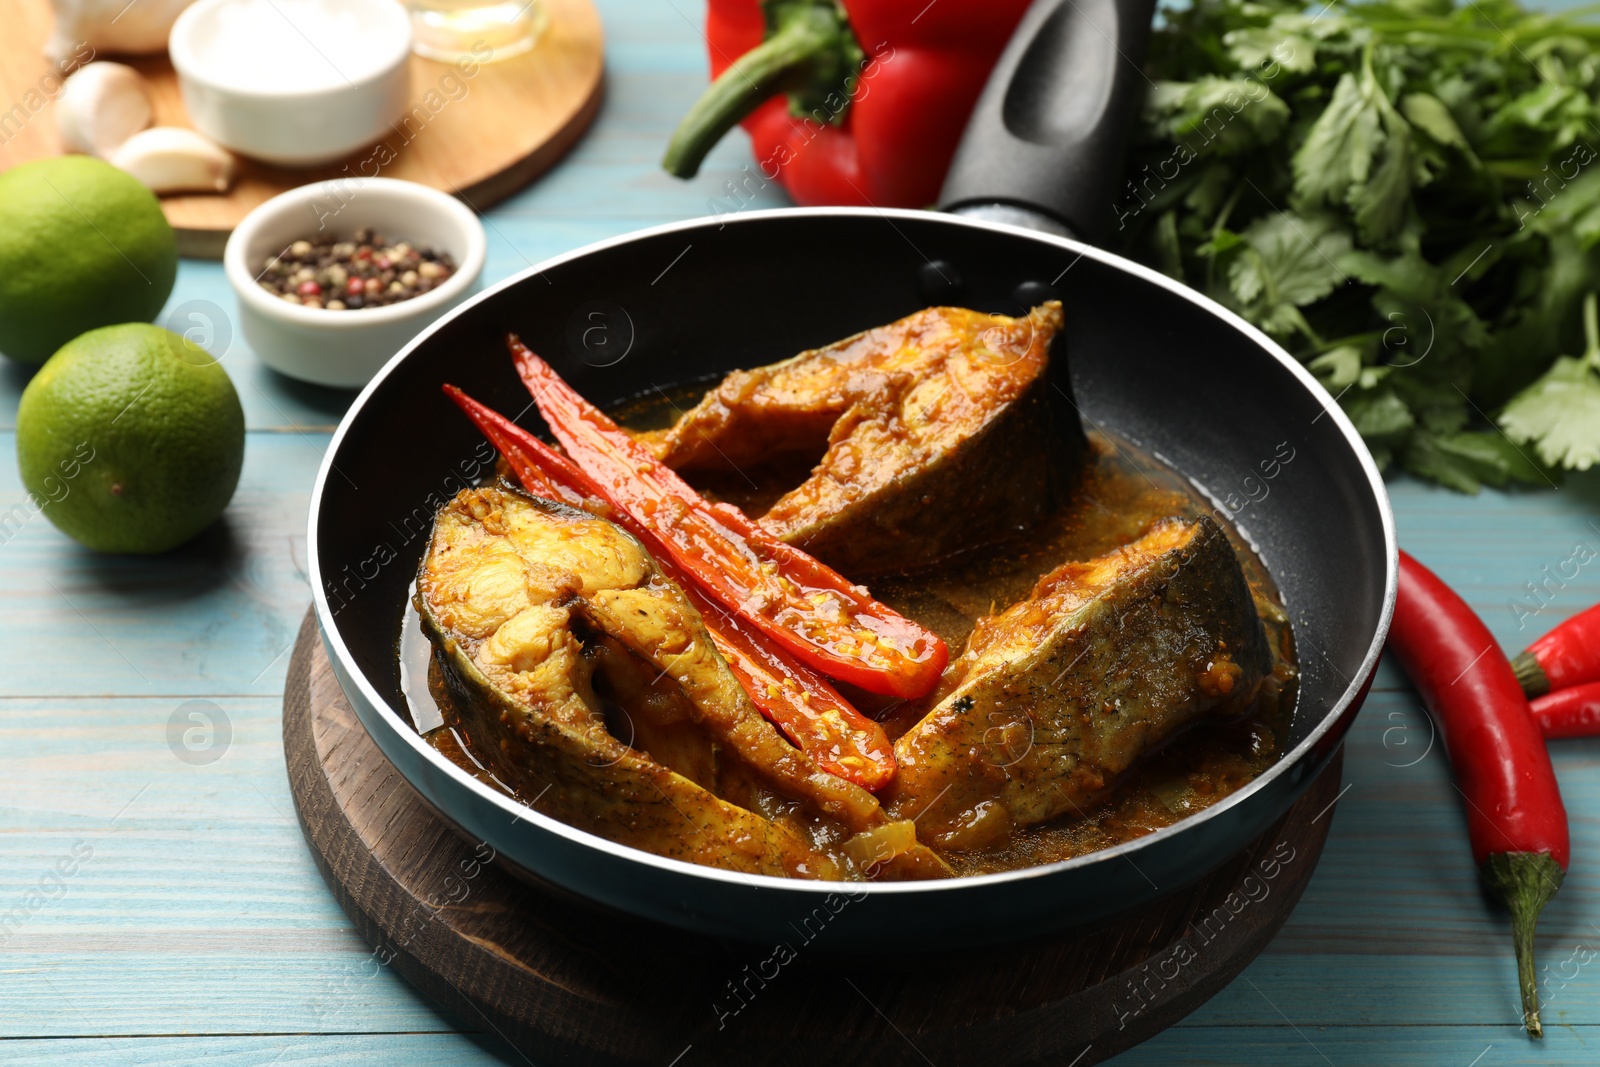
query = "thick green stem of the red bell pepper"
(661, 0, 864, 178)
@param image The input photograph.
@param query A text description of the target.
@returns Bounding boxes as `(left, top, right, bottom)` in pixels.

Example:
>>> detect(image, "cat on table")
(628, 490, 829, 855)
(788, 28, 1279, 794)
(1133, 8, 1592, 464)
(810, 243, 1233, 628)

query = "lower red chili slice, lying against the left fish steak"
(445, 386, 894, 790)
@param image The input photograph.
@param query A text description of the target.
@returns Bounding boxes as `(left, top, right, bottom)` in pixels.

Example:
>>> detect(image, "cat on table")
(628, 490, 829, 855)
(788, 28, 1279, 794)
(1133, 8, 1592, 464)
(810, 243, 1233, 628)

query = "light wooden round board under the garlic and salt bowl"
(0, 0, 605, 259)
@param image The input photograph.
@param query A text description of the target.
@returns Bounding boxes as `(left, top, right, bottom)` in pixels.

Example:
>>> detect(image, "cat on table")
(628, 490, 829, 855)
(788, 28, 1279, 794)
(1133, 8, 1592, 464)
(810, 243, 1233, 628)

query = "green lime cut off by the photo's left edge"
(0, 155, 178, 363)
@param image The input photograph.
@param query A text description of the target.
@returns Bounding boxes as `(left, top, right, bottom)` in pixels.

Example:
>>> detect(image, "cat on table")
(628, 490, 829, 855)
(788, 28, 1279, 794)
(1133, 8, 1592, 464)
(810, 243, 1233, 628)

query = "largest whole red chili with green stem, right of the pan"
(1389, 552, 1570, 1037)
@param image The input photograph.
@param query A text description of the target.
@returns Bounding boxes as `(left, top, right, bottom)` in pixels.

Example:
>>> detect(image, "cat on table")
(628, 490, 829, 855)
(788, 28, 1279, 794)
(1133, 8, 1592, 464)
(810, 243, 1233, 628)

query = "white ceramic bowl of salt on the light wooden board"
(168, 0, 411, 166)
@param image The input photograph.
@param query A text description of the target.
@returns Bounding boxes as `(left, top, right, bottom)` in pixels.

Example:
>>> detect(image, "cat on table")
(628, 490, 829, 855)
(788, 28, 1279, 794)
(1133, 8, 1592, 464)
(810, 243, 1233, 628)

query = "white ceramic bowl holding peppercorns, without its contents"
(222, 178, 486, 389)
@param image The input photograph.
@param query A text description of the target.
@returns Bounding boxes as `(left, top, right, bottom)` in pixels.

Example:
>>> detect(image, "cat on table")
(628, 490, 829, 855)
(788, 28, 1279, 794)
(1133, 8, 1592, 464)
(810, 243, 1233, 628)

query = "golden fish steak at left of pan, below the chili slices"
(416, 488, 947, 878)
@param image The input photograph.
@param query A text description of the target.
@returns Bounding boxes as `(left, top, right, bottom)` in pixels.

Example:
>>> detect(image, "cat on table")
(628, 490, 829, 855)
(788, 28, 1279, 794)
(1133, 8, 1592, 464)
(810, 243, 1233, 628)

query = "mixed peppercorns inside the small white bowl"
(256, 229, 456, 312)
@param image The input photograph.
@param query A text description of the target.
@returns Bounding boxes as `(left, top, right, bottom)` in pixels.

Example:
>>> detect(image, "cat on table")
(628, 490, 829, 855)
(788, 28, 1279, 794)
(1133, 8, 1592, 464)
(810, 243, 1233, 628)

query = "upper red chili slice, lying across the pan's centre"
(507, 336, 950, 697)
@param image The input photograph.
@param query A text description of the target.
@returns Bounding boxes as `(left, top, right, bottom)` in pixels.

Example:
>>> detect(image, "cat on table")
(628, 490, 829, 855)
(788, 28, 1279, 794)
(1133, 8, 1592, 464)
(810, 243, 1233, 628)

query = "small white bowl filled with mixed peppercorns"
(222, 178, 486, 389)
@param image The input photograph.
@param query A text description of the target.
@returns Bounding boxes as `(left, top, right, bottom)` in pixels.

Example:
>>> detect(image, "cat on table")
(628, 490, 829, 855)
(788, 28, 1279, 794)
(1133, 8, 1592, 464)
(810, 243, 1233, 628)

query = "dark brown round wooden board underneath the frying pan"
(283, 616, 1342, 1067)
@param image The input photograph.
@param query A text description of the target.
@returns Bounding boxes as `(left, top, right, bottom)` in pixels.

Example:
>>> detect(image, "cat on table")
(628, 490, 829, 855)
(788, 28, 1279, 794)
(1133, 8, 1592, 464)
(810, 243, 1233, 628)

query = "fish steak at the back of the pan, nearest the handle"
(645, 301, 1086, 574)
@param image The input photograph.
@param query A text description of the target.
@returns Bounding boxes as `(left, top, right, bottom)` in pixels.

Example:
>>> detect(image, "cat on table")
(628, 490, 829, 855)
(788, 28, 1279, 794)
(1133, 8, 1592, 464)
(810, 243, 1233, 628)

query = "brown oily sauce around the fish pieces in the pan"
(397, 387, 1296, 875)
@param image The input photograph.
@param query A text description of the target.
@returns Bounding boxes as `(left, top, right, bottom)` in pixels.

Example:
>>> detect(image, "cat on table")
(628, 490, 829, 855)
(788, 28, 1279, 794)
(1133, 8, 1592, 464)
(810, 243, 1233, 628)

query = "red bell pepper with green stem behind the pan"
(661, 0, 1029, 208)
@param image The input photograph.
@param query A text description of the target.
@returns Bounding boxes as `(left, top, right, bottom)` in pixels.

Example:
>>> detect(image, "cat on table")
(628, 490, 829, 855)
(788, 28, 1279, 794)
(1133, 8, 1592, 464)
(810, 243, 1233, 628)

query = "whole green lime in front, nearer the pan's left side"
(16, 323, 245, 552)
